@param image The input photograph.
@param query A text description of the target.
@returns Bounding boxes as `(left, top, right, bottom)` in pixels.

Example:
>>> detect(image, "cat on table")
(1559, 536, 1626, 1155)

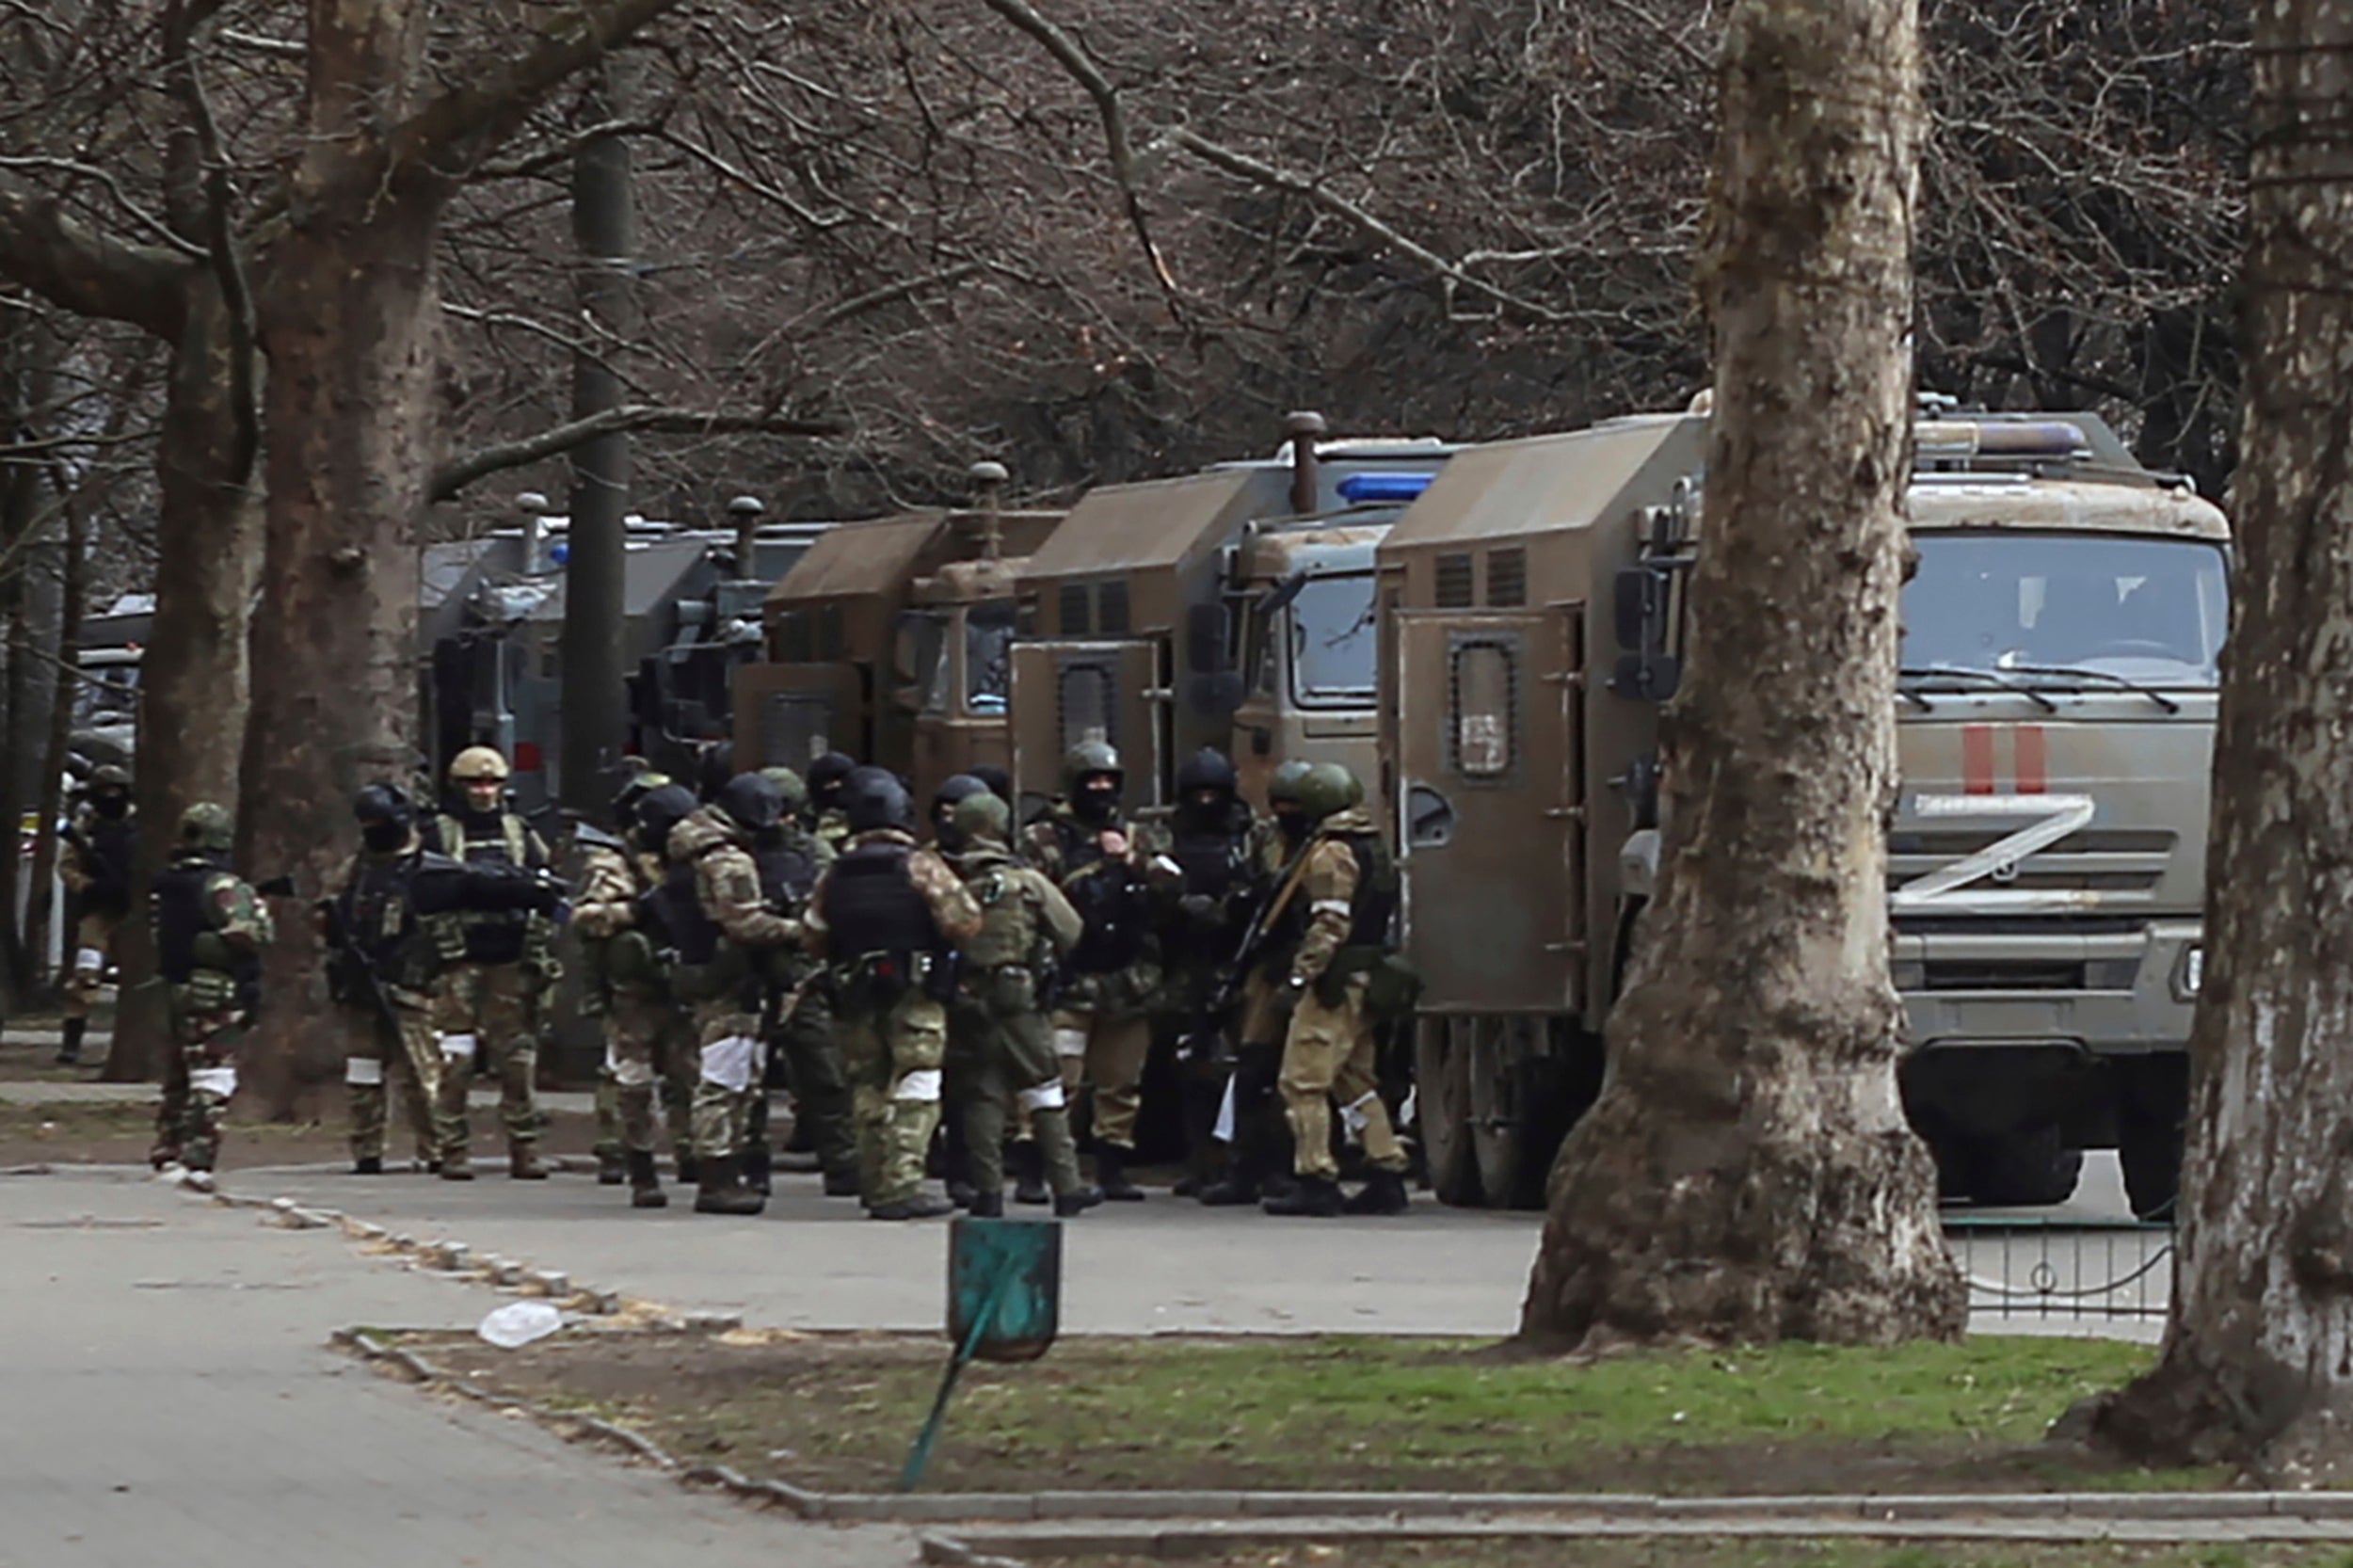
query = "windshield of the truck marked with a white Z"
(1904, 532, 2231, 687)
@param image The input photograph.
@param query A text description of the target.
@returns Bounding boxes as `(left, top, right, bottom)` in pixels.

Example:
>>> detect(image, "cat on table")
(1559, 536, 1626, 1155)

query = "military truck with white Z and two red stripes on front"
(1379, 402, 2229, 1215)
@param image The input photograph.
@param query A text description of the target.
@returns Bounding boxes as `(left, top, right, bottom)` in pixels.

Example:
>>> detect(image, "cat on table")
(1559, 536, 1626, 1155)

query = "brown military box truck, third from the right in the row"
(734, 464, 1064, 801)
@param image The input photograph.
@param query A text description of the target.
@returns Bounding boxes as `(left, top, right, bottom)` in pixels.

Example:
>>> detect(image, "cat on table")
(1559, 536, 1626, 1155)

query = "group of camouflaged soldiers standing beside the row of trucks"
(55, 725, 1412, 1220)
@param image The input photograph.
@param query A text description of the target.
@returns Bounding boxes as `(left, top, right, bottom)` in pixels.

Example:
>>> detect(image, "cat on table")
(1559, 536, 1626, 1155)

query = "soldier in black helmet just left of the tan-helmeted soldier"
(323, 784, 452, 1175)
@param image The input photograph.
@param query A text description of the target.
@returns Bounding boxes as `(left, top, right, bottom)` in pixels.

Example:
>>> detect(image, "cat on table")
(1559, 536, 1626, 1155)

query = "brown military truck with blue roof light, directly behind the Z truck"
(1012, 414, 1452, 812)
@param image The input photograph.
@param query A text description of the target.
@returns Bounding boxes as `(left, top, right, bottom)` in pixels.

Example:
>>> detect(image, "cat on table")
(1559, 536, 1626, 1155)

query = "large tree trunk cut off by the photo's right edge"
(2089, 0, 2353, 1485)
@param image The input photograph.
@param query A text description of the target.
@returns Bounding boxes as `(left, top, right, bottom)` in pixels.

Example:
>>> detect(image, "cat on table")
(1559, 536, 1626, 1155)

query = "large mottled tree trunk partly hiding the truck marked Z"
(1520, 0, 1965, 1347)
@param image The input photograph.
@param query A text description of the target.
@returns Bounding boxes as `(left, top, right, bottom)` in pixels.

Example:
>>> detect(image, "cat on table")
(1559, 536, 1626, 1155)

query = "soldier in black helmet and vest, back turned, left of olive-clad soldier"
(808, 767, 982, 1220)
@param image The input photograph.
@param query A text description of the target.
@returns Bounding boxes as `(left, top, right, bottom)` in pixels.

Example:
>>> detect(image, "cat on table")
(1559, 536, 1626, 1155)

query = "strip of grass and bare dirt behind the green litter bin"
(391, 1335, 2226, 1495)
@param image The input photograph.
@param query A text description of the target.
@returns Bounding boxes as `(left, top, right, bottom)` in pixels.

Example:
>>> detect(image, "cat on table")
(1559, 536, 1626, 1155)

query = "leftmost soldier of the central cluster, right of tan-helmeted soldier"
(572, 772, 696, 1208)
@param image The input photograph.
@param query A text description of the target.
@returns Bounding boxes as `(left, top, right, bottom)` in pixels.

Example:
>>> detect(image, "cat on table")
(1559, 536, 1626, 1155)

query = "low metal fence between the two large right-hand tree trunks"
(1944, 1217, 2174, 1320)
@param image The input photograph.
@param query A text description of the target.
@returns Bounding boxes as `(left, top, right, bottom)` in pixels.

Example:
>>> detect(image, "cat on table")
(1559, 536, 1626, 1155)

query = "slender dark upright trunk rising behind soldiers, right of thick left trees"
(558, 55, 638, 812)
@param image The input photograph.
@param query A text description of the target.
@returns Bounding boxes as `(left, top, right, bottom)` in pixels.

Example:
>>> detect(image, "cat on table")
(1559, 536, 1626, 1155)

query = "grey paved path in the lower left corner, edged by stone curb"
(0, 1175, 916, 1568)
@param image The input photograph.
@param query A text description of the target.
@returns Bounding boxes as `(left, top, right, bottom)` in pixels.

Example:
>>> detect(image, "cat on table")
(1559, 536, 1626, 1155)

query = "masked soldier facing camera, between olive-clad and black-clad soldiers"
(1016, 742, 1170, 1203)
